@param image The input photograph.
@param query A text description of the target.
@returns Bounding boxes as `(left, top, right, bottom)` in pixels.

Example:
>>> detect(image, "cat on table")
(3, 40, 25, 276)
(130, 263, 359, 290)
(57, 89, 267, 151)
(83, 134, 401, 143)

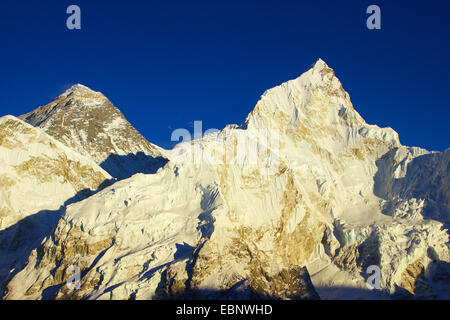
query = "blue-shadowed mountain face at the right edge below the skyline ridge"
(374, 147, 450, 226)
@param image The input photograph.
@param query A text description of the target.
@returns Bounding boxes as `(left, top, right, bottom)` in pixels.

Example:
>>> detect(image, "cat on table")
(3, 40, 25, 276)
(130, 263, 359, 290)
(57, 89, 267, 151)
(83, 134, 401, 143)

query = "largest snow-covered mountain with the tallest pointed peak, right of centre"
(4, 59, 450, 299)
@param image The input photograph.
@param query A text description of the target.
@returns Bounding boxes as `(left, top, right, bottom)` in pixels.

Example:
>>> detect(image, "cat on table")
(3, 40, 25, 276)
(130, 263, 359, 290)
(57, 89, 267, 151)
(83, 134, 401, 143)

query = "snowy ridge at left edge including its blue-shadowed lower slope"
(0, 116, 111, 294)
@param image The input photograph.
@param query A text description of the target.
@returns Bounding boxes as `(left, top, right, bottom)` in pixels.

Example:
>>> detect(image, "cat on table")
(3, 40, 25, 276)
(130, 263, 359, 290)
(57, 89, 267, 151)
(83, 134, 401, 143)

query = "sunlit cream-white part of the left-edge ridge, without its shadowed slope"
(0, 116, 111, 229)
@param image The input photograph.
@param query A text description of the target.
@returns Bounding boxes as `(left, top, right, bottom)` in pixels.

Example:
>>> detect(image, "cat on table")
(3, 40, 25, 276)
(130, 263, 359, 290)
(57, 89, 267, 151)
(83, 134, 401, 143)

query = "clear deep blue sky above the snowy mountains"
(0, 0, 450, 151)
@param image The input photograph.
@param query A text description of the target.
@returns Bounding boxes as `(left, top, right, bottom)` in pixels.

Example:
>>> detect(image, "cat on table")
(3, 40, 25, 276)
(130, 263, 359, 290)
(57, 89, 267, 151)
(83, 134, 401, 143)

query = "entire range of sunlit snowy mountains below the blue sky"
(0, 59, 450, 300)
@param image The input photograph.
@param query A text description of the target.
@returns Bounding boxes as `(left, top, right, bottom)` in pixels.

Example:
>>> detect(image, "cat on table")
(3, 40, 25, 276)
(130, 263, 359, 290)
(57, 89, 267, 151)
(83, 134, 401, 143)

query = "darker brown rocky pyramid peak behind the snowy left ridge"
(20, 84, 169, 179)
